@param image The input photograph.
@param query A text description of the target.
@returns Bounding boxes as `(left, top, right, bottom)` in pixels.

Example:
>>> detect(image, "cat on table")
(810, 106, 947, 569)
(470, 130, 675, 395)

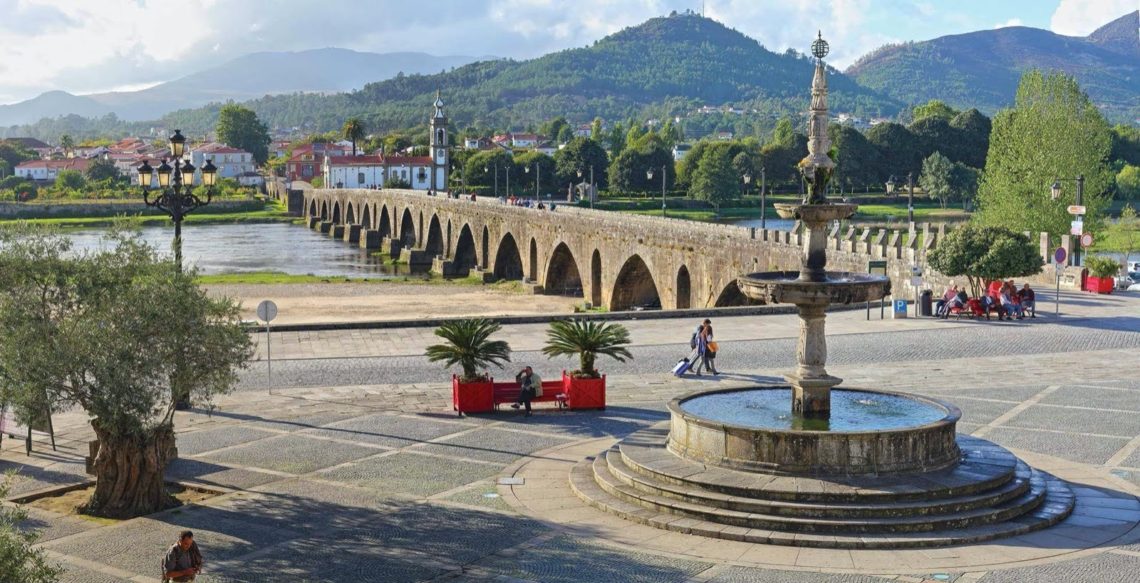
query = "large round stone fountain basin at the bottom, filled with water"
(668, 387, 961, 476)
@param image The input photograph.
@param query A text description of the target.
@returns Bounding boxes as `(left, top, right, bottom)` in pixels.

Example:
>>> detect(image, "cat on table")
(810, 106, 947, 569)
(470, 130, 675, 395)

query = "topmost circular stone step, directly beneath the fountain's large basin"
(617, 427, 1018, 503)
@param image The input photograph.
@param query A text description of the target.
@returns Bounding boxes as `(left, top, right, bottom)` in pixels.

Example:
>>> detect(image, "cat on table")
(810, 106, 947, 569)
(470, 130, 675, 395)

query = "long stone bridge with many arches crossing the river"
(303, 189, 1048, 310)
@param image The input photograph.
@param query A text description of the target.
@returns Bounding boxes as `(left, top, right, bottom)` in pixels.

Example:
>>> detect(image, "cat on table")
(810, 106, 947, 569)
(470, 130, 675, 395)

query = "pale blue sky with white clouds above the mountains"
(0, 0, 1140, 104)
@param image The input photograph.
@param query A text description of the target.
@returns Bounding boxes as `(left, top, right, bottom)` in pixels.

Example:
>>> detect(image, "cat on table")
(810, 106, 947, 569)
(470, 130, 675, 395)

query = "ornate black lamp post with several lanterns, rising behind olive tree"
(138, 130, 218, 270)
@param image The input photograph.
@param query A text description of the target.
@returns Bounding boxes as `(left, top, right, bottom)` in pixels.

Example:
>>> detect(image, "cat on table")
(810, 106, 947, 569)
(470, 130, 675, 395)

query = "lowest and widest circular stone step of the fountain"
(570, 459, 1075, 549)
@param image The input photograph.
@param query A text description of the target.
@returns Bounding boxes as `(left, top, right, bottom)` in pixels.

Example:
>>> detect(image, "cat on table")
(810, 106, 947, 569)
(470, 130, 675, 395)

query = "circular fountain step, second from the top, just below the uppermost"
(604, 447, 1031, 518)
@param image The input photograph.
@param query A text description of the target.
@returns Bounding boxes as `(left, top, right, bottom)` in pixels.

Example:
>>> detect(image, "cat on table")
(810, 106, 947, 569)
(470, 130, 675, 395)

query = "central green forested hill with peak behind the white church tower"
(166, 15, 899, 132)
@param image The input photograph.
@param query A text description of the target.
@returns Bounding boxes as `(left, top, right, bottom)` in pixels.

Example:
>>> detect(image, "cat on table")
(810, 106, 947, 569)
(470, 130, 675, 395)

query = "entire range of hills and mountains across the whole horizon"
(0, 11, 1140, 137)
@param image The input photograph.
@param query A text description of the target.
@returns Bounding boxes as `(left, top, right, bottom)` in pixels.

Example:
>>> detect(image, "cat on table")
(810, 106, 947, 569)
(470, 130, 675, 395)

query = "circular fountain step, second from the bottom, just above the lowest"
(592, 456, 1045, 534)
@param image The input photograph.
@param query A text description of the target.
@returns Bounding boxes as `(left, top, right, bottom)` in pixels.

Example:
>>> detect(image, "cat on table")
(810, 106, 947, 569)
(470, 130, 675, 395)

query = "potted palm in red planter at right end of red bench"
(543, 319, 633, 408)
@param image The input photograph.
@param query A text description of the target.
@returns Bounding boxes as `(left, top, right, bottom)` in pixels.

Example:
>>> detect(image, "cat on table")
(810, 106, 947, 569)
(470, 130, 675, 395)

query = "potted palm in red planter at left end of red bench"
(424, 318, 511, 416)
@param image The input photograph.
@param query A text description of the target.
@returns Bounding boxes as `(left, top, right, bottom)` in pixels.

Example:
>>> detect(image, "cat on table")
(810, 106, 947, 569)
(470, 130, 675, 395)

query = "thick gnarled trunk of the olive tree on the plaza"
(87, 421, 178, 518)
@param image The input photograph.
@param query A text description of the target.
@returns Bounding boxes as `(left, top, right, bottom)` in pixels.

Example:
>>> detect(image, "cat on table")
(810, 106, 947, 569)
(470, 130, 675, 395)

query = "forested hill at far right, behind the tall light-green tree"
(847, 11, 1140, 121)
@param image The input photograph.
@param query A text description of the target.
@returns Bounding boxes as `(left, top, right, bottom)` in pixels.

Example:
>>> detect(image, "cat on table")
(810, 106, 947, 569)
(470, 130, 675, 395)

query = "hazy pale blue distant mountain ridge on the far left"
(0, 48, 476, 127)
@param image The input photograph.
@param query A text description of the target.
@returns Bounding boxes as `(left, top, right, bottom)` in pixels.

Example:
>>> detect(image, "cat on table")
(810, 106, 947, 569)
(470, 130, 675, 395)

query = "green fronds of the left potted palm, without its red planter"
(424, 318, 511, 382)
